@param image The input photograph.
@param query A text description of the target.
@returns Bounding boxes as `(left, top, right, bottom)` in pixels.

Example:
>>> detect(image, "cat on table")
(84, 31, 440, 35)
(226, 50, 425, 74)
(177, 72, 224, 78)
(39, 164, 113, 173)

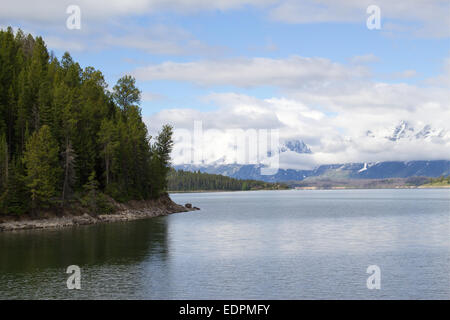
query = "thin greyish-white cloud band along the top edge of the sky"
(0, 0, 450, 37)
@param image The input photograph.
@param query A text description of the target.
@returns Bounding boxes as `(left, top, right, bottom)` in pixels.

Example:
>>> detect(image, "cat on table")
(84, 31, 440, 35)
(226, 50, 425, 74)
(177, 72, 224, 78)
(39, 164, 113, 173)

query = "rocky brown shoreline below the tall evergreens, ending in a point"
(0, 196, 200, 232)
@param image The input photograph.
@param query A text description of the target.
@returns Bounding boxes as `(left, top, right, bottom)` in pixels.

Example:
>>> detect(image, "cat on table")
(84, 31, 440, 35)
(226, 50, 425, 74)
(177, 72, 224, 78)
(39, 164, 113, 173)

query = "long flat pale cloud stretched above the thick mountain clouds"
(133, 56, 368, 87)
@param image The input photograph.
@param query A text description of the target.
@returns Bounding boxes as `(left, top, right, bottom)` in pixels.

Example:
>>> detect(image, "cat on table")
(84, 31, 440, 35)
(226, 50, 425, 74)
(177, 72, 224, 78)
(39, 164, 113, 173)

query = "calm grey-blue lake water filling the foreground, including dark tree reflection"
(0, 189, 450, 299)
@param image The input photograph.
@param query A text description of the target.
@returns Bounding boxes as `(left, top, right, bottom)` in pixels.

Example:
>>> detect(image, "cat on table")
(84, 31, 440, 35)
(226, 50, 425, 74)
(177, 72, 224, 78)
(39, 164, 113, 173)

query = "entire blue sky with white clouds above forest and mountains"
(0, 0, 450, 169)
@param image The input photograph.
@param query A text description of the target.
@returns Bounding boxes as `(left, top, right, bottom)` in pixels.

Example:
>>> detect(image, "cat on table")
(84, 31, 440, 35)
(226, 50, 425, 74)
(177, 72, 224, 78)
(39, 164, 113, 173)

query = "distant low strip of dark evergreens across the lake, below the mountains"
(167, 169, 288, 191)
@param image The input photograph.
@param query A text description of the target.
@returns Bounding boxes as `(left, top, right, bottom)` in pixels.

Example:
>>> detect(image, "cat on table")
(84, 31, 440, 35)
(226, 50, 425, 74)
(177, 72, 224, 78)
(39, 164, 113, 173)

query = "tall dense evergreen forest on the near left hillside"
(0, 28, 173, 215)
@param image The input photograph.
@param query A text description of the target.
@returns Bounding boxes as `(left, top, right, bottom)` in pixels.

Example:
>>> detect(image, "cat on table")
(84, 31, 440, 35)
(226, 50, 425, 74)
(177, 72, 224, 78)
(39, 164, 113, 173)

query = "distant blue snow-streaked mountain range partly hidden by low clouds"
(174, 121, 450, 182)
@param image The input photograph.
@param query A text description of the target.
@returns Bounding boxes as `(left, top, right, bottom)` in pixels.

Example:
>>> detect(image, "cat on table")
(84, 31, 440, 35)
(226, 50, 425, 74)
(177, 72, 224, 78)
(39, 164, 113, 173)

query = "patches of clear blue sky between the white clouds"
(55, 8, 450, 115)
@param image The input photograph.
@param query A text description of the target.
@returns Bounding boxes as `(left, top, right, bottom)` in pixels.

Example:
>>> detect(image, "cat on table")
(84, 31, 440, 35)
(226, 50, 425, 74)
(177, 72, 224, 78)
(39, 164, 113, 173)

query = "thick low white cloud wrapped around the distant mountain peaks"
(147, 88, 450, 169)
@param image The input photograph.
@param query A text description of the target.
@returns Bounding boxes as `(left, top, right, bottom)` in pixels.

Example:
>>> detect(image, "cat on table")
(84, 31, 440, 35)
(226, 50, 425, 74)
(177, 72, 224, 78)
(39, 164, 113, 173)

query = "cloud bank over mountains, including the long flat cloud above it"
(144, 57, 450, 169)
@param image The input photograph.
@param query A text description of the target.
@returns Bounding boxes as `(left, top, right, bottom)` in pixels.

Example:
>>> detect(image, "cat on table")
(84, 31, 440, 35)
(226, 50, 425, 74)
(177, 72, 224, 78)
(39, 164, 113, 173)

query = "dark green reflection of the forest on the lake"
(0, 217, 168, 274)
